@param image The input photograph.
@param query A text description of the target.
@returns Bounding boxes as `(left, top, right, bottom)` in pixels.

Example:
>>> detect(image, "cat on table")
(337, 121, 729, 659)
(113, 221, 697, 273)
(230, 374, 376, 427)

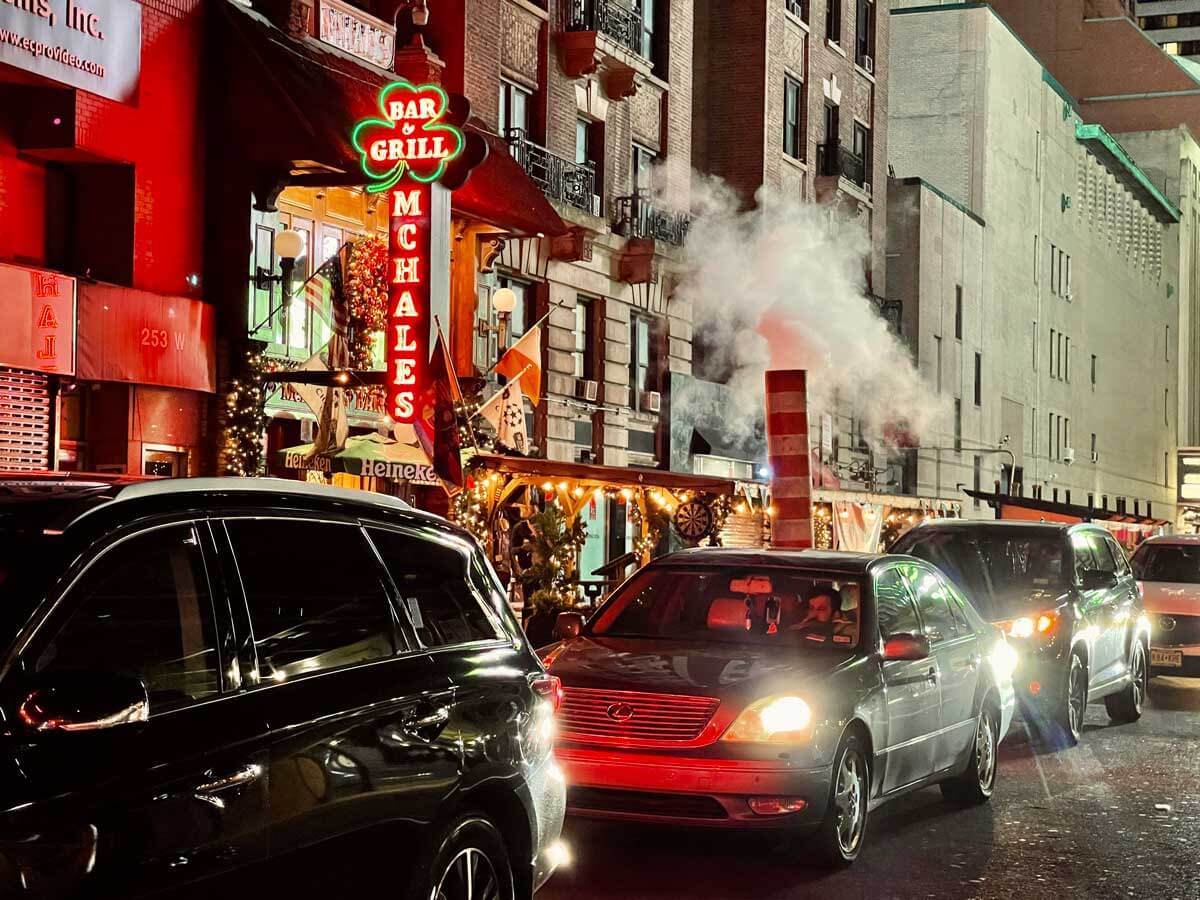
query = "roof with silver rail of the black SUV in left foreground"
(0, 476, 461, 542)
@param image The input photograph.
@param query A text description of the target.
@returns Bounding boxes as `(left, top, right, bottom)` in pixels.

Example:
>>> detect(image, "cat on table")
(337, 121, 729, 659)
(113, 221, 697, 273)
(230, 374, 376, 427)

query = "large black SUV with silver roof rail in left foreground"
(0, 479, 565, 900)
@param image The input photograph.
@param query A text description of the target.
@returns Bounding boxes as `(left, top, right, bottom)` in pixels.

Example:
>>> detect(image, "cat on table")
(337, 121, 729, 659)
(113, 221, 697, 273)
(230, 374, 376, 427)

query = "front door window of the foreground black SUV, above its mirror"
(34, 524, 221, 713)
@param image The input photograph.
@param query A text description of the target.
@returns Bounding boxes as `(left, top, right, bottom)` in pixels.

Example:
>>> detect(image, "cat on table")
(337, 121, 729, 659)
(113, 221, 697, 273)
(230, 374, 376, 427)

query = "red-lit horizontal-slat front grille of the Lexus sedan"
(558, 688, 720, 745)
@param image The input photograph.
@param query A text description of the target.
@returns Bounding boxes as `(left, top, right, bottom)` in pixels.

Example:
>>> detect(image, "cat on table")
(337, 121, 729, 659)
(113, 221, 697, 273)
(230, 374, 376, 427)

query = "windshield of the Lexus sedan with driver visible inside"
(592, 566, 863, 649)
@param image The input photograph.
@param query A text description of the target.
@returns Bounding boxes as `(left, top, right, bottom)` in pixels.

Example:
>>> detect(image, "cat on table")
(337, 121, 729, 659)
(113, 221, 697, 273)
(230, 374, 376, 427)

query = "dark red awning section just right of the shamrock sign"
(452, 126, 568, 236)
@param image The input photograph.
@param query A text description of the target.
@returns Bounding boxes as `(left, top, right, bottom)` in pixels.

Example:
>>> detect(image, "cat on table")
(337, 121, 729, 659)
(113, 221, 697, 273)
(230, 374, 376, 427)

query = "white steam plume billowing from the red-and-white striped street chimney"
(679, 180, 946, 438)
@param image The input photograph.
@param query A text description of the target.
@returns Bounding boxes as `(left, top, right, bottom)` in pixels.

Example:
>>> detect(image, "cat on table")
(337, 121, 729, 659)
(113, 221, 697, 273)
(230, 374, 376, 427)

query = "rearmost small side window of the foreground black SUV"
(370, 528, 500, 647)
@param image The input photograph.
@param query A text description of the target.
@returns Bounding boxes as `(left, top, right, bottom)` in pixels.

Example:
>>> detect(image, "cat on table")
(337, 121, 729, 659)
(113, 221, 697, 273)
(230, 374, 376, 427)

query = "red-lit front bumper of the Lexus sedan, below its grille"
(557, 746, 833, 828)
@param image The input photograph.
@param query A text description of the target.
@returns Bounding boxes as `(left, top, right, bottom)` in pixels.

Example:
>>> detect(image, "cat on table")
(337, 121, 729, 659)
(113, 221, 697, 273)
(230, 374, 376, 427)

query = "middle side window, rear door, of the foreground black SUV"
(226, 518, 396, 682)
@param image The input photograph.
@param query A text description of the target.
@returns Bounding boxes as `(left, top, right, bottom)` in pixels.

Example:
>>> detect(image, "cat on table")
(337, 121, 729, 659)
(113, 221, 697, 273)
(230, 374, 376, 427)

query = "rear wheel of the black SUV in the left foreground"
(408, 812, 516, 900)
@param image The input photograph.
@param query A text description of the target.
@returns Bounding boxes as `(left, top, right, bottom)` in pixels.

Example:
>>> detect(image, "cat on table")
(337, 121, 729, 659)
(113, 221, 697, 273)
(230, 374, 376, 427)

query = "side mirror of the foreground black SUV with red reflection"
(17, 672, 150, 732)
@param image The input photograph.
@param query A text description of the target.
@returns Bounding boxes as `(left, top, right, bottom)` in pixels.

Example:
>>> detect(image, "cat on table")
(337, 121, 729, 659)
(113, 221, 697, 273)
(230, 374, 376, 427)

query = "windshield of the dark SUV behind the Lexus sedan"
(893, 526, 1070, 622)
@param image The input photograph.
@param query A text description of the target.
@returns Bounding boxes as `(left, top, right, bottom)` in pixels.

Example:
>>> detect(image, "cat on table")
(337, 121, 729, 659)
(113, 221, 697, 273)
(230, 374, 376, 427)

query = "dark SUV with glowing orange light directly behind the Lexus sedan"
(892, 521, 1150, 744)
